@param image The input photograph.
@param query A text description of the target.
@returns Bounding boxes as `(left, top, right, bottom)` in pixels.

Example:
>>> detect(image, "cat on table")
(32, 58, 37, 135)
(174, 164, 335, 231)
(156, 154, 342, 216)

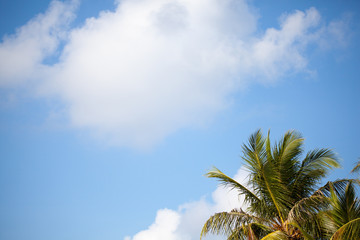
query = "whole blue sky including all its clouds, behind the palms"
(0, 0, 360, 240)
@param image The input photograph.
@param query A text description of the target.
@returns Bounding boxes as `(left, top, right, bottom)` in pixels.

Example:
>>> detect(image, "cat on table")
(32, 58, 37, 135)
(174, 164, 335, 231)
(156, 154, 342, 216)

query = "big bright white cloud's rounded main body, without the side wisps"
(42, 0, 255, 146)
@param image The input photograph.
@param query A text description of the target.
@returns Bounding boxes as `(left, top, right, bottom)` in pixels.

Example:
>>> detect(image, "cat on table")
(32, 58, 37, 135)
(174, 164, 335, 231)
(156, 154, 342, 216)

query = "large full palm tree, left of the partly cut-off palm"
(200, 130, 344, 240)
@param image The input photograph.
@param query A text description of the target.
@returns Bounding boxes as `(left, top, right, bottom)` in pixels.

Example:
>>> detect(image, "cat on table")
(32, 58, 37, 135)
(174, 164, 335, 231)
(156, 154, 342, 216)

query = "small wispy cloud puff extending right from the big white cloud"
(248, 8, 320, 79)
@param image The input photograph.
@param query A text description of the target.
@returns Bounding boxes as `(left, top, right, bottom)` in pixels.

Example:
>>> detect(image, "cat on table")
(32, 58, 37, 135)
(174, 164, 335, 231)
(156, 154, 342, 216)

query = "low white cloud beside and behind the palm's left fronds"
(124, 169, 247, 240)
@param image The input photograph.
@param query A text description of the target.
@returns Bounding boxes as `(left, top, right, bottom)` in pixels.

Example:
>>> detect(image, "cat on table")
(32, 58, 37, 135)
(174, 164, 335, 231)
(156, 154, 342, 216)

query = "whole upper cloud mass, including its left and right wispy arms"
(0, 0, 343, 147)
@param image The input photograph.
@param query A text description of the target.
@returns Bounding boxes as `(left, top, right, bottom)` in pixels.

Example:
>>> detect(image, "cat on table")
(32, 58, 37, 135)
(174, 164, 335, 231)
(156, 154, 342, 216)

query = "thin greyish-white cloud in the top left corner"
(0, 1, 77, 87)
